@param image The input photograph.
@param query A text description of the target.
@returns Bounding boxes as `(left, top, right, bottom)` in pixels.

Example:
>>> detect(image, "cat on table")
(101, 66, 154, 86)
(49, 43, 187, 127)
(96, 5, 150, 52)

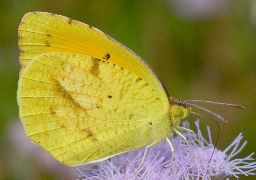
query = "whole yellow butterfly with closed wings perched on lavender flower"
(17, 12, 194, 165)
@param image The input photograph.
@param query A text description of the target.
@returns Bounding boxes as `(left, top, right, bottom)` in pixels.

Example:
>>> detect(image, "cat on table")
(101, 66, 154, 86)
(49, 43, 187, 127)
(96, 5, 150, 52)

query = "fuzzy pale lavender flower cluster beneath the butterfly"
(77, 121, 256, 180)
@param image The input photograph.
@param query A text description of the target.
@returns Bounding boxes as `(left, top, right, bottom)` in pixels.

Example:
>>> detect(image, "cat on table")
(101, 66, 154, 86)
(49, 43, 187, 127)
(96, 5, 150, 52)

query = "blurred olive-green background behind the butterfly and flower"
(0, 0, 256, 179)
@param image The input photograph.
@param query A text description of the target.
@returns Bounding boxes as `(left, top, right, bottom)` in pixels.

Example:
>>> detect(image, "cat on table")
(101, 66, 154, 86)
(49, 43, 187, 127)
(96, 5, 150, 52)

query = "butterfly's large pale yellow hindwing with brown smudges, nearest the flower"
(18, 53, 170, 165)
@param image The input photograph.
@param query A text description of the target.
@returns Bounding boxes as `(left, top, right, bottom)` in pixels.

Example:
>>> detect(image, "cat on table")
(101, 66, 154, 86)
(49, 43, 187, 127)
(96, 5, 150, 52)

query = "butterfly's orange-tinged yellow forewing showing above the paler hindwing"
(19, 12, 169, 113)
